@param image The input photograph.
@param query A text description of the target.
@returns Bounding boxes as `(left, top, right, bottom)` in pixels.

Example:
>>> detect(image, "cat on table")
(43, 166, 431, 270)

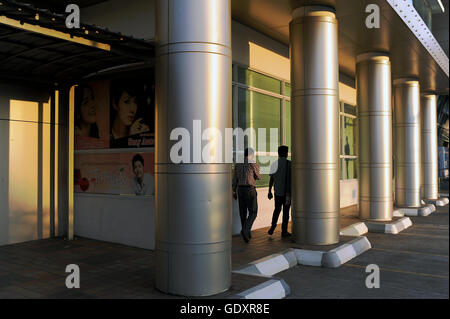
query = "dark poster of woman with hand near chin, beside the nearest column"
(110, 79, 154, 148)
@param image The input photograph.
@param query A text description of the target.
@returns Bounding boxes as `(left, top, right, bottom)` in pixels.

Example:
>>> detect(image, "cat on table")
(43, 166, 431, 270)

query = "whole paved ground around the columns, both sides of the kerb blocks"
(0, 206, 449, 299)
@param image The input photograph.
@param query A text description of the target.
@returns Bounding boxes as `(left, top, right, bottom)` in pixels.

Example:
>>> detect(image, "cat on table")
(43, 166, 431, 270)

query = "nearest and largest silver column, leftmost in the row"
(155, 0, 232, 296)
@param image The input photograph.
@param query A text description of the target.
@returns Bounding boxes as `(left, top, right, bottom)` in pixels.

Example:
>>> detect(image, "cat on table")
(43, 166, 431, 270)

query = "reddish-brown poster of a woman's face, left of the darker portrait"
(74, 81, 110, 149)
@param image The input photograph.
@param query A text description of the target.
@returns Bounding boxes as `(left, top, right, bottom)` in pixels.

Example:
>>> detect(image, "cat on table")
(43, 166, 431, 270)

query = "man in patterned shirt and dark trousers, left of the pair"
(233, 148, 261, 243)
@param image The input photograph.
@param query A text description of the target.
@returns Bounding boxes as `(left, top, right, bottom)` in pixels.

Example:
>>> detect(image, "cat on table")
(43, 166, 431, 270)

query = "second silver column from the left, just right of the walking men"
(290, 6, 340, 245)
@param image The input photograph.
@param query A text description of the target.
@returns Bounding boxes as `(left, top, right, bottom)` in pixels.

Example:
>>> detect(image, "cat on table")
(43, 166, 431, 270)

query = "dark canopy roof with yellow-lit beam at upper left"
(0, 0, 154, 83)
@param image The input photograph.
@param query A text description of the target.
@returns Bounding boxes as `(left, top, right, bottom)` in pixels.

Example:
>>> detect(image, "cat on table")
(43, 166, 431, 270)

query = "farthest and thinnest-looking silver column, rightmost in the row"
(420, 93, 439, 200)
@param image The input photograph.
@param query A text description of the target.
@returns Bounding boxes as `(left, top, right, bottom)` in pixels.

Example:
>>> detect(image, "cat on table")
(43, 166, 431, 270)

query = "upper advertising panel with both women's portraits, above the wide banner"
(74, 78, 155, 150)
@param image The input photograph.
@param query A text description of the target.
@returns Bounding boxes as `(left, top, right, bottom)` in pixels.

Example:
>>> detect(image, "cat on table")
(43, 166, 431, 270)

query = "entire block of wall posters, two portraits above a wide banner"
(74, 77, 155, 196)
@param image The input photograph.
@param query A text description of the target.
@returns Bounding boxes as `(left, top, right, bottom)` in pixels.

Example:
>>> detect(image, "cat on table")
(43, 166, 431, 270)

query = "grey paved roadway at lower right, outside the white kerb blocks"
(277, 206, 449, 299)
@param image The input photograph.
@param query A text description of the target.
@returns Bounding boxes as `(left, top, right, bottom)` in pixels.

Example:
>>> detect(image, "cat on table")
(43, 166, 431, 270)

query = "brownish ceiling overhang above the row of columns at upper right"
(232, 0, 448, 94)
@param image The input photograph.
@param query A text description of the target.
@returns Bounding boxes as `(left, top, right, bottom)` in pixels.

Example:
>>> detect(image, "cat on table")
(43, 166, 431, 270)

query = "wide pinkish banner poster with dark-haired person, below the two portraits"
(74, 153, 155, 196)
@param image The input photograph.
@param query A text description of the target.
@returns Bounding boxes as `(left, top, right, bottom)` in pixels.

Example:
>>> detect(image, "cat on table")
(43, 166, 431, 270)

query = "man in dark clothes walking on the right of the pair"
(268, 145, 291, 237)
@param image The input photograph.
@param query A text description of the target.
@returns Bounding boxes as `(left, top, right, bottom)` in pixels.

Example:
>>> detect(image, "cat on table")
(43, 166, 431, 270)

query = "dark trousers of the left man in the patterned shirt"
(238, 186, 258, 236)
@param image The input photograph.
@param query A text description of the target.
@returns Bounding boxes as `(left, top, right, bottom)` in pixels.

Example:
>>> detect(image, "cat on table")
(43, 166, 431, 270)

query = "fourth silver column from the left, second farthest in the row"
(394, 78, 421, 207)
